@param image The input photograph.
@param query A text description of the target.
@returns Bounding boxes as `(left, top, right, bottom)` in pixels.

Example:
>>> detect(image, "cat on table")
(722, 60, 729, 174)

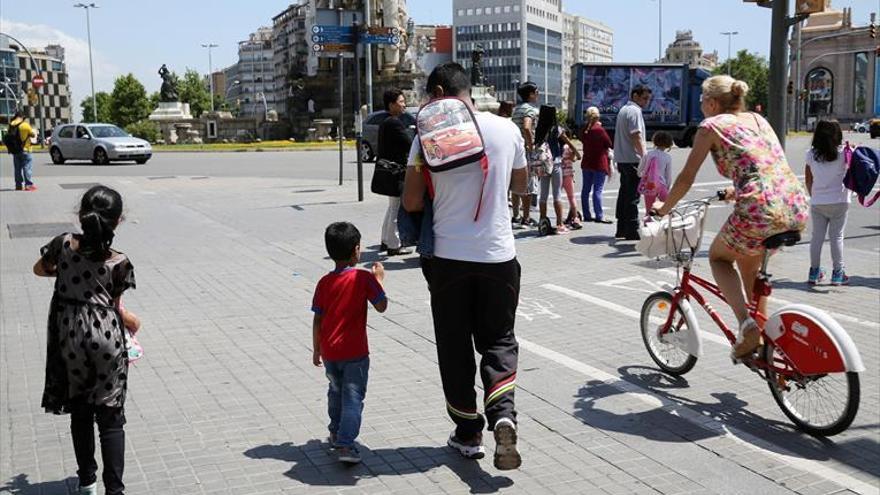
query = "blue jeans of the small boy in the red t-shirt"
(324, 356, 370, 447)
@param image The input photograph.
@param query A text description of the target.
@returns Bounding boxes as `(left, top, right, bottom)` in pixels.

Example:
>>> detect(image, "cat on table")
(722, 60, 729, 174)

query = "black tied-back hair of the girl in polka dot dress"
(79, 186, 122, 261)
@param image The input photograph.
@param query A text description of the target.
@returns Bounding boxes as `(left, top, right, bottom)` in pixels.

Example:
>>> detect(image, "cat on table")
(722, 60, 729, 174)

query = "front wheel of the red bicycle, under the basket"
(641, 291, 697, 375)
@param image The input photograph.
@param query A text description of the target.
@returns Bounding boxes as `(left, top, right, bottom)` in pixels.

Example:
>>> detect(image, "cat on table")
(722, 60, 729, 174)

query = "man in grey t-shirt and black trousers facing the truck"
(614, 84, 651, 241)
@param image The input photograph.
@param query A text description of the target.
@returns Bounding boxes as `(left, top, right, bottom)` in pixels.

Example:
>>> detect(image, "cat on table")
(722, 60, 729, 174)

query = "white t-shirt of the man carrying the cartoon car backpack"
(409, 112, 526, 263)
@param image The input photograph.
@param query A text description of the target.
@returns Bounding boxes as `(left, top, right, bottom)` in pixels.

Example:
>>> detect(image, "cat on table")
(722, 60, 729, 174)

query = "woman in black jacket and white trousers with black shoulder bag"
(376, 88, 412, 256)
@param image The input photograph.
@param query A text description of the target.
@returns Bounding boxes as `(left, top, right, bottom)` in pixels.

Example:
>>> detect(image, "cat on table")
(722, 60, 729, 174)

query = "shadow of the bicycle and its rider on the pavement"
(574, 366, 880, 476)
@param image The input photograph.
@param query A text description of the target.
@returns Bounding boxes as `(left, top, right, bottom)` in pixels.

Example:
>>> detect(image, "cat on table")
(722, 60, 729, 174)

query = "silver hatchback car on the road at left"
(49, 124, 153, 165)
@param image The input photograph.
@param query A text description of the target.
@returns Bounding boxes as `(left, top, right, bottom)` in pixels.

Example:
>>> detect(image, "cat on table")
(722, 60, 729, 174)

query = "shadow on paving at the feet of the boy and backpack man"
(244, 439, 513, 493)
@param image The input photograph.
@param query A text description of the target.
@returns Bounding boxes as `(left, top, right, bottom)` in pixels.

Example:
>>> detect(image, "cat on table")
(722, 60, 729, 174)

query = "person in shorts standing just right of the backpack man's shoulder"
(511, 81, 543, 228)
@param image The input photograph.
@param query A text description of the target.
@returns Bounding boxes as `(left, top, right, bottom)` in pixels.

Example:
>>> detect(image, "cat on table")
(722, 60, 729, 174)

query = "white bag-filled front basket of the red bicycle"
(636, 208, 706, 259)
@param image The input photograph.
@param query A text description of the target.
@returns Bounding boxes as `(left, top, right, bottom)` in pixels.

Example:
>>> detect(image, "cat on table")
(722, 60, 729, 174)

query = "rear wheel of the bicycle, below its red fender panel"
(764, 341, 860, 436)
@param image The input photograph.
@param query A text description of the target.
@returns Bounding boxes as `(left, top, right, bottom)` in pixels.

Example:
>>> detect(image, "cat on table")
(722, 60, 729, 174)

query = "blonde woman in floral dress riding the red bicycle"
(654, 76, 809, 359)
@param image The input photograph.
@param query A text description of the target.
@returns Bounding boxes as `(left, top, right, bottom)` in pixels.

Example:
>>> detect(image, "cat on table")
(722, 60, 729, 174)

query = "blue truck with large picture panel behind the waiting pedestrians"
(568, 63, 711, 147)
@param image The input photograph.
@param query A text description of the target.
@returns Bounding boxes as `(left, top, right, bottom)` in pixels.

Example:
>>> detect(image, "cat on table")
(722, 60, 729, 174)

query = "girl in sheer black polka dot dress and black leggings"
(34, 186, 137, 494)
